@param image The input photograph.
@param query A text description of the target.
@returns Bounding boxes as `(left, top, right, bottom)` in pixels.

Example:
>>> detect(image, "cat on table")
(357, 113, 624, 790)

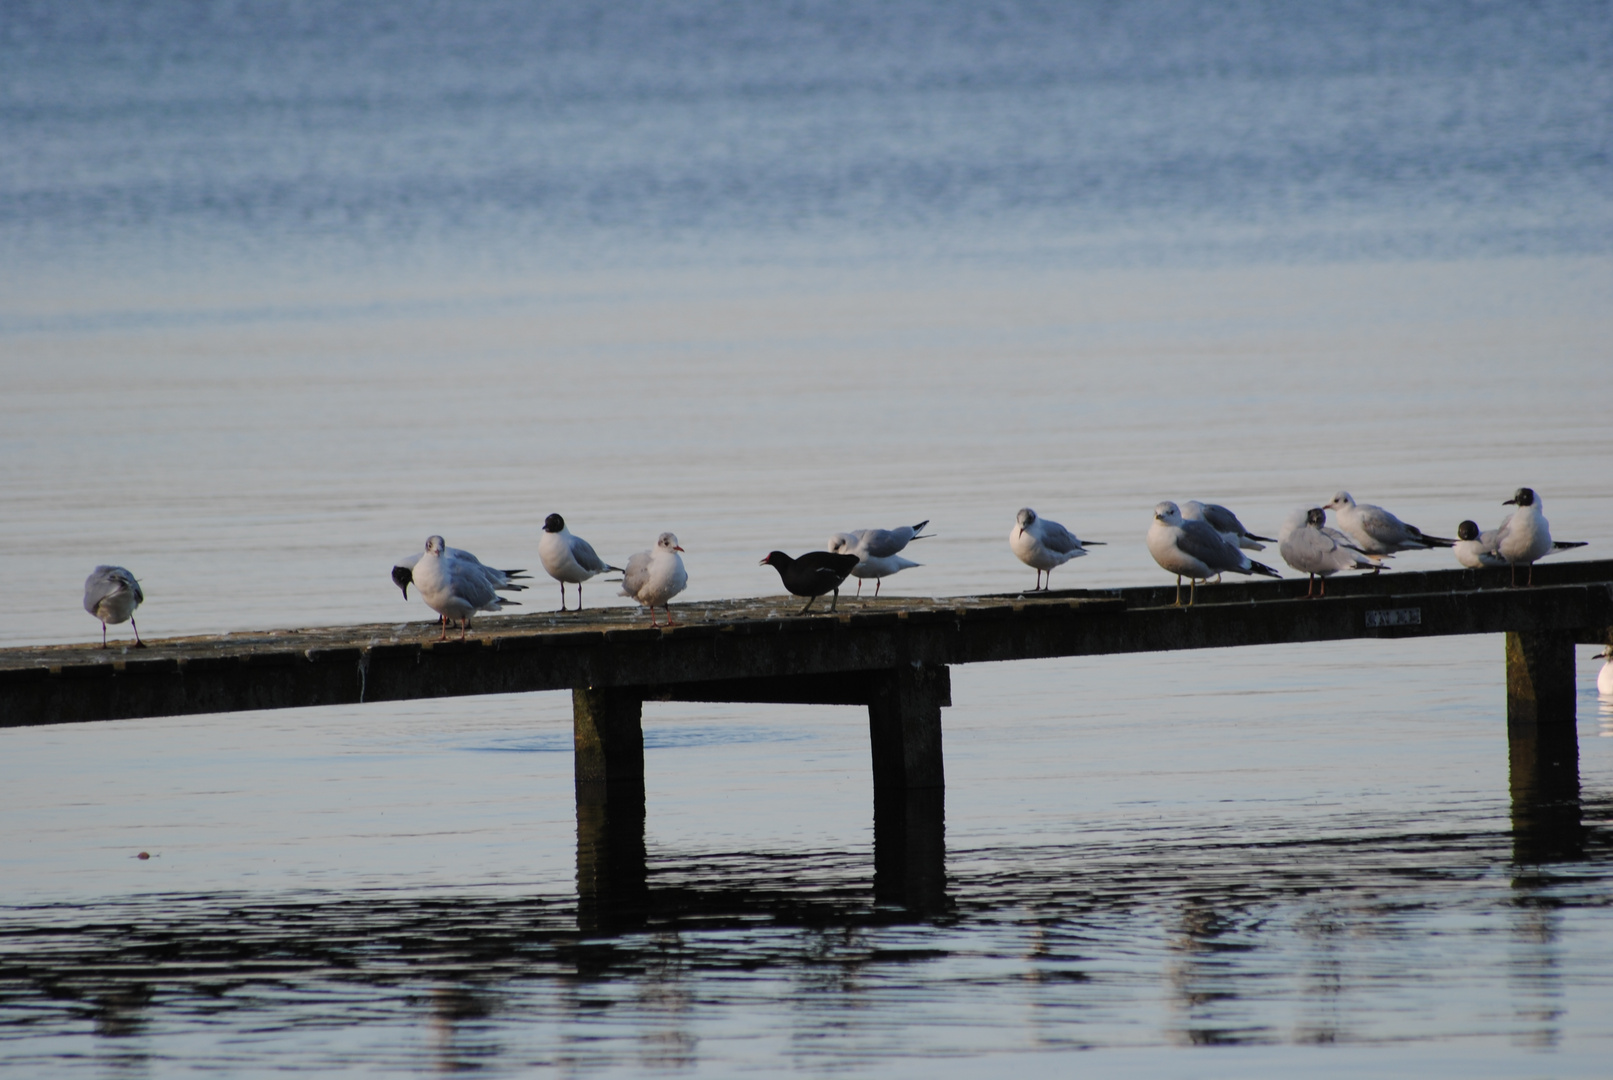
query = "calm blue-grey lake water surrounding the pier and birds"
(0, 2, 1613, 1077)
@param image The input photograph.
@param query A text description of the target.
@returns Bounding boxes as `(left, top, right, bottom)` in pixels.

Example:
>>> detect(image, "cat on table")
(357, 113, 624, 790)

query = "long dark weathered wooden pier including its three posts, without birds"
(0, 561, 1613, 928)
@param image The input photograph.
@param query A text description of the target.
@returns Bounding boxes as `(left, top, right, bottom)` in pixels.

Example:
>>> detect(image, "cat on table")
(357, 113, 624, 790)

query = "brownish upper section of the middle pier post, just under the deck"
(868, 664, 952, 791)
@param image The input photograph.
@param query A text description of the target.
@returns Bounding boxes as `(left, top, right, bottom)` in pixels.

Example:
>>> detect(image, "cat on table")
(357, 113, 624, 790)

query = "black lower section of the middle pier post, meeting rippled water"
(874, 787, 947, 916)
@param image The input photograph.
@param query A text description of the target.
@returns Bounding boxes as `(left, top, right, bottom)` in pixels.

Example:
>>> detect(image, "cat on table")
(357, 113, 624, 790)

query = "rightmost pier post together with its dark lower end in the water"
(1507, 632, 1584, 864)
